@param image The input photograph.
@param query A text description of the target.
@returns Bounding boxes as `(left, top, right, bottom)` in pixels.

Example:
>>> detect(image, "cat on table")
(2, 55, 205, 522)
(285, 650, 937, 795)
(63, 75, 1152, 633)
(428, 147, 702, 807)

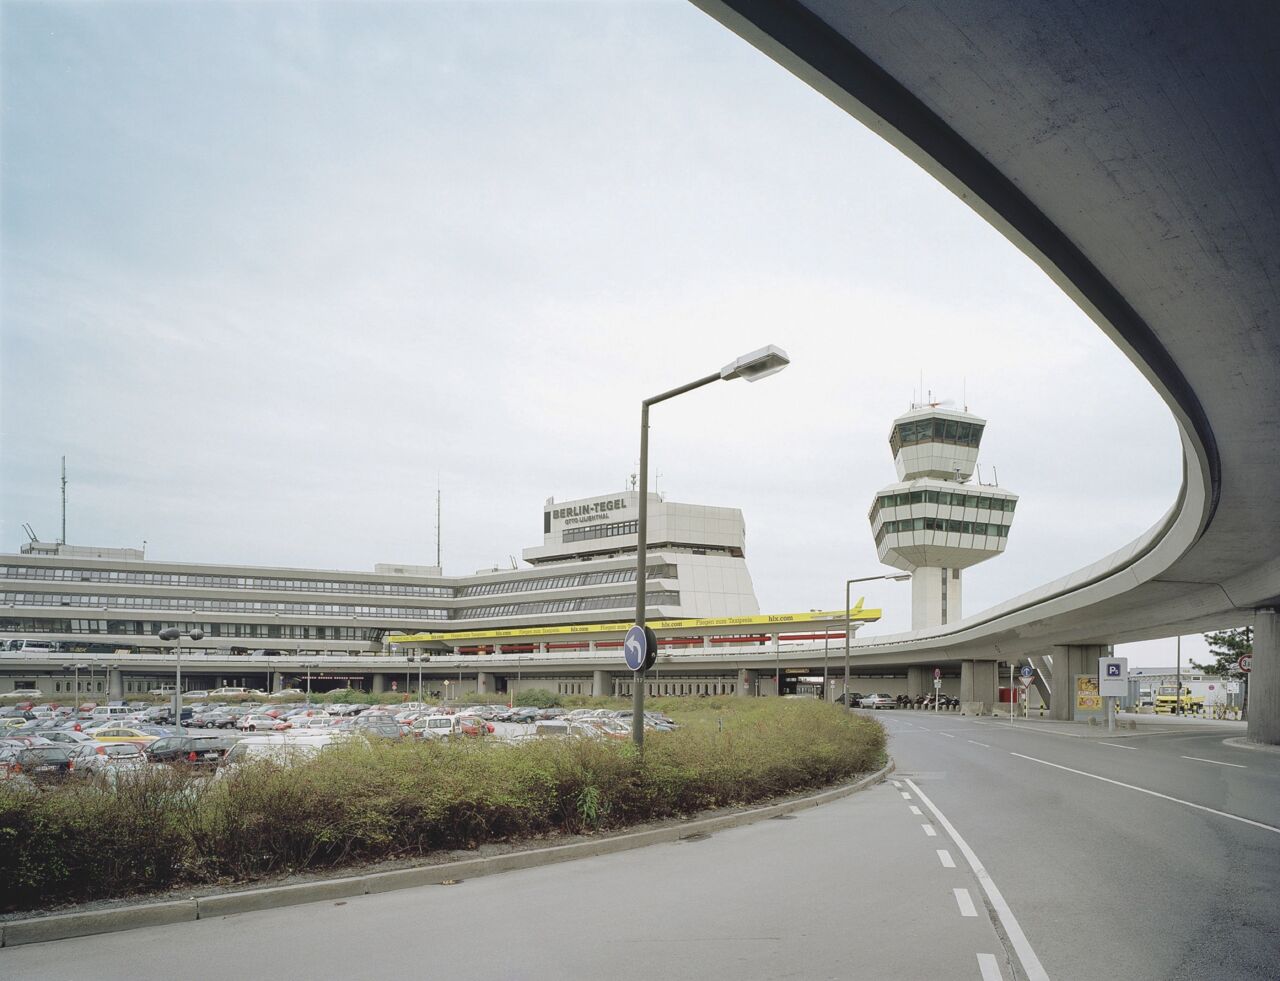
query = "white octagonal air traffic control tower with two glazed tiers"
(868, 402, 1018, 630)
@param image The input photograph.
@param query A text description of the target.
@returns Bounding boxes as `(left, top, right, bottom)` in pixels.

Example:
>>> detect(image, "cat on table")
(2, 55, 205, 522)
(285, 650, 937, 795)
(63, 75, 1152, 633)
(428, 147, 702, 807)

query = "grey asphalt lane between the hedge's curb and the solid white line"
(0, 776, 1015, 981)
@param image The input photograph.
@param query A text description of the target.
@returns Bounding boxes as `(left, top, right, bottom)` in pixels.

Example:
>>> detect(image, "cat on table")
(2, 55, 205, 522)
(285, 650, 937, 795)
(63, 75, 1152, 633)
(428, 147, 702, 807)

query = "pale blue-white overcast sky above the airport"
(0, 0, 1218, 663)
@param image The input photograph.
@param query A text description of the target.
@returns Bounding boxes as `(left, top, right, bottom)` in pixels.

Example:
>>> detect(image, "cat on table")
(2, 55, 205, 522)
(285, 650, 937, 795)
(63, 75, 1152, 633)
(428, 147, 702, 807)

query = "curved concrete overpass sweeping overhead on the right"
(694, 0, 1280, 743)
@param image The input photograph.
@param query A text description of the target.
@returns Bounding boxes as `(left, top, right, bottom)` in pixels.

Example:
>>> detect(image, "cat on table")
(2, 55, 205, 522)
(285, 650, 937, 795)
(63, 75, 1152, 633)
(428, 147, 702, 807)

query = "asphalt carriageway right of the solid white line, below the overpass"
(878, 712, 1280, 981)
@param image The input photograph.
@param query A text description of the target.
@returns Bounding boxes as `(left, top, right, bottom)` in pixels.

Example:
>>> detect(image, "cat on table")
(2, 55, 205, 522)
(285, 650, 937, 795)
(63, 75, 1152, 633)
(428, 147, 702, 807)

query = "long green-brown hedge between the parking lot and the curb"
(0, 698, 884, 909)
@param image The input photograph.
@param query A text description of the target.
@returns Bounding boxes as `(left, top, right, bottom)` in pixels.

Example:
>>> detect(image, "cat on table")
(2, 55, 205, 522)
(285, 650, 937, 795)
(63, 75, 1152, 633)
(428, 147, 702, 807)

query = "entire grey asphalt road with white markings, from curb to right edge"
(0, 712, 1280, 981)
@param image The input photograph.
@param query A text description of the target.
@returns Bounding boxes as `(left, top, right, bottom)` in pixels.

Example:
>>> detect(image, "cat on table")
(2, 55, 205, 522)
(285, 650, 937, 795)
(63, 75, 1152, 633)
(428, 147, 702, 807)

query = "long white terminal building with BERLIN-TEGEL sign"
(0, 491, 759, 692)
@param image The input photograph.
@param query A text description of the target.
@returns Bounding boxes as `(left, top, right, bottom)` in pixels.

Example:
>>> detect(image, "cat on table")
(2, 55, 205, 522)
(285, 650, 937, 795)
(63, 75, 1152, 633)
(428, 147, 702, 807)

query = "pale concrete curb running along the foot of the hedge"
(0, 759, 895, 948)
